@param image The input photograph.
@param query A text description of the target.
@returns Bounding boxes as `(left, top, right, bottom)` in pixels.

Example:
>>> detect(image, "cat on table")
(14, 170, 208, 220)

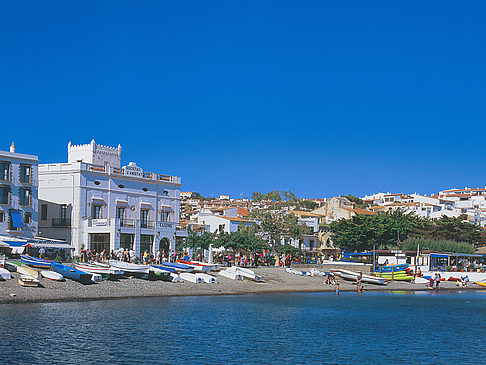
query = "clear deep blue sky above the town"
(0, 0, 486, 197)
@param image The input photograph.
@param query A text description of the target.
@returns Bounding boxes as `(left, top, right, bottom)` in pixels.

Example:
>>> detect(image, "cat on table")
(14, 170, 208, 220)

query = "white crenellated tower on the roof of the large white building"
(68, 139, 121, 168)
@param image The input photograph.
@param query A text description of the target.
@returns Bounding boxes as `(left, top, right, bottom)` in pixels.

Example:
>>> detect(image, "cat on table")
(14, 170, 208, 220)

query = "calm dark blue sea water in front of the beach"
(0, 292, 486, 364)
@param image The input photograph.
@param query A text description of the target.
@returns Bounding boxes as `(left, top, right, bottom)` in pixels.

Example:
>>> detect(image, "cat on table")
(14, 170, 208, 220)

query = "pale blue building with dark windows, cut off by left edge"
(0, 143, 39, 239)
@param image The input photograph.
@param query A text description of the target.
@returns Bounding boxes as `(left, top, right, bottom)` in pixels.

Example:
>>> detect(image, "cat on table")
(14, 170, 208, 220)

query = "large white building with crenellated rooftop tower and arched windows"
(39, 140, 185, 256)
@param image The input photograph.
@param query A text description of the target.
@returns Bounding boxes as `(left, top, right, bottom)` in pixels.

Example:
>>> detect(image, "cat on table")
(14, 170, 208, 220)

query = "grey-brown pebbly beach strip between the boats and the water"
(0, 267, 480, 304)
